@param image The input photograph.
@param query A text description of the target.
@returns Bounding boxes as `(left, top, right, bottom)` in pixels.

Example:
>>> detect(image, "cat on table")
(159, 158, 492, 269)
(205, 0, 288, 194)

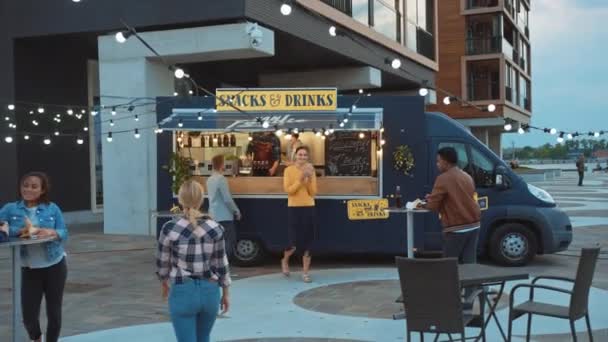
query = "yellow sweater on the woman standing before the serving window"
(283, 165, 317, 207)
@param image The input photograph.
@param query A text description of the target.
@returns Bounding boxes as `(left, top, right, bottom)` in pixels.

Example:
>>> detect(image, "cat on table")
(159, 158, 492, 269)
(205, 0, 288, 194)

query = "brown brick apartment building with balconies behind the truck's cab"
(431, 0, 532, 154)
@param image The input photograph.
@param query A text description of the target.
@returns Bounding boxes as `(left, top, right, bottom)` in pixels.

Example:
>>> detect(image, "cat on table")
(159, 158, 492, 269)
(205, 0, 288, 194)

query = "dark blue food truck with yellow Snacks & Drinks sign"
(157, 88, 572, 265)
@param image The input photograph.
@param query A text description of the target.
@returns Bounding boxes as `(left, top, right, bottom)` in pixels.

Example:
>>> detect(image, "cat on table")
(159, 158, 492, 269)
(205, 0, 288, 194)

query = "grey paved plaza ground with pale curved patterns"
(0, 174, 608, 342)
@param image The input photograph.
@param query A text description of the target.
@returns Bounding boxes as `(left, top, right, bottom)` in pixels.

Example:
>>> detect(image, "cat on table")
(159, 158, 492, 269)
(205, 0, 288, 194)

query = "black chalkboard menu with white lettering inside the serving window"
(325, 131, 372, 176)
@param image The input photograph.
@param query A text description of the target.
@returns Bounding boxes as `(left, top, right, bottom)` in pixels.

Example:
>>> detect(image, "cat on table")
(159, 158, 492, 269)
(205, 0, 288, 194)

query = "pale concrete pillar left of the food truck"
(99, 57, 174, 235)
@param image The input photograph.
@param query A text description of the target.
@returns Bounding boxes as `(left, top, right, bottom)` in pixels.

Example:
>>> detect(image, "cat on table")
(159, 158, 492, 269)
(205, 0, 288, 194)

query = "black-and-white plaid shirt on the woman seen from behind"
(156, 217, 231, 287)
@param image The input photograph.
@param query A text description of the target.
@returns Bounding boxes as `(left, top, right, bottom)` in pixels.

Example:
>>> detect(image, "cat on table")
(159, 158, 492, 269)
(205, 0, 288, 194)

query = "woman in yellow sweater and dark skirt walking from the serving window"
(281, 146, 317, 283)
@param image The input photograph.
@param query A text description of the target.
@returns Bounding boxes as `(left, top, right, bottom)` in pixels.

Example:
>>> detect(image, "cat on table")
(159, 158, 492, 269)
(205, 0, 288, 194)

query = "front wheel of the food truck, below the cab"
(490, 223, 538, 266)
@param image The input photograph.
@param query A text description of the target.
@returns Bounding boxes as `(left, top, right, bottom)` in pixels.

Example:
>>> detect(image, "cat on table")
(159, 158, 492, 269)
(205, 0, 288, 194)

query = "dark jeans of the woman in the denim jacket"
(21, 258, 68, 342)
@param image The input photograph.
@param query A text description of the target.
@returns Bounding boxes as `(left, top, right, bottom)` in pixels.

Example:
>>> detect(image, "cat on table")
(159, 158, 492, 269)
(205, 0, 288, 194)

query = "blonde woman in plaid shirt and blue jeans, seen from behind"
(157, 180, 230, 342)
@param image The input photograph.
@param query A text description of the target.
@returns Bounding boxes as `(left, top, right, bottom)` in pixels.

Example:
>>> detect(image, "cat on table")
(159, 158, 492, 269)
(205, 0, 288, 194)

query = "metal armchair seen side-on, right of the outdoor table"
(509, 248, 600, 342)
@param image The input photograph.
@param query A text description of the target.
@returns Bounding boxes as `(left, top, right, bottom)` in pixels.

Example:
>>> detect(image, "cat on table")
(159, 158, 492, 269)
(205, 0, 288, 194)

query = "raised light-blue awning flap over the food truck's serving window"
(158, 108, 382, 132)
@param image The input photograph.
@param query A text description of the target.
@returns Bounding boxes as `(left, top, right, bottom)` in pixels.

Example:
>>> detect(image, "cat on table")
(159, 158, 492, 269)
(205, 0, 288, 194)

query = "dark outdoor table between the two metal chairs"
(393, 264, 530, 341)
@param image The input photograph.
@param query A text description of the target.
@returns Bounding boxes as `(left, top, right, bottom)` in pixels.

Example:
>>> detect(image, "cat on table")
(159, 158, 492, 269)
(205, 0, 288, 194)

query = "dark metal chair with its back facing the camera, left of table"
(396, 257, 485, 342)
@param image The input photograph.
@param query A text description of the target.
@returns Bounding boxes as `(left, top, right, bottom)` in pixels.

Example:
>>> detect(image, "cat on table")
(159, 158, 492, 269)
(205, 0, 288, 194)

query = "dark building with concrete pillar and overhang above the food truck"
(0, 0, 438, 234)
